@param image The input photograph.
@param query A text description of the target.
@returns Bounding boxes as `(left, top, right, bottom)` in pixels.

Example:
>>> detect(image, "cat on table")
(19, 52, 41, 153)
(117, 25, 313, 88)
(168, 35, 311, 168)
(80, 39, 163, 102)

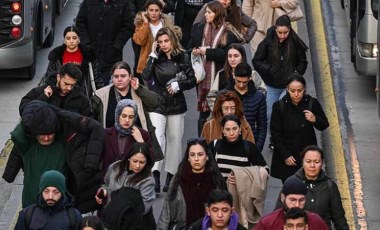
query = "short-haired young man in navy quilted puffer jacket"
(226, 62, 267, 151)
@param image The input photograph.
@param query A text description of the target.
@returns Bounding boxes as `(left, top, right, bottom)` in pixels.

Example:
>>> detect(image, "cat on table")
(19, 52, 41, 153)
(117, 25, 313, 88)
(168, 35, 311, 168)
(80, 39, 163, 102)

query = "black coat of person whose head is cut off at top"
(76, 0, 133, 71)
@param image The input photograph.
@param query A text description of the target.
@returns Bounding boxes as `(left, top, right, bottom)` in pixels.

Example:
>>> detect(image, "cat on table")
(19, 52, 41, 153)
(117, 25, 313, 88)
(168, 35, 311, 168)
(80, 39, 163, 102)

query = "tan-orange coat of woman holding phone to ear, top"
(133, 12, 173, 74)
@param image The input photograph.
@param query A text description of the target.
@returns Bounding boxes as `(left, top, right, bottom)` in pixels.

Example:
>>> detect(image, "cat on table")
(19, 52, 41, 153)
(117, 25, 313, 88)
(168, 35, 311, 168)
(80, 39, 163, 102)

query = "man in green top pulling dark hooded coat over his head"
(3, 100, 104, 213)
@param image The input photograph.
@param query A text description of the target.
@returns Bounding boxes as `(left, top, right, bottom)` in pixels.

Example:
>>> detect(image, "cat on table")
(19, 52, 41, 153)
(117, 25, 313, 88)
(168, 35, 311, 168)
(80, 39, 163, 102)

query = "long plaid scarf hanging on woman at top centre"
(198, 23, 225, 112)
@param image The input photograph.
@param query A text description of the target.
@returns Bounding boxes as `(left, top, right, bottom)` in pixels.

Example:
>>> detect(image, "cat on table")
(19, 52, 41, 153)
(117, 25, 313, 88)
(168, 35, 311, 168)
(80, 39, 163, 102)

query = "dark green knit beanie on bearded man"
(39, 170, 66, 194)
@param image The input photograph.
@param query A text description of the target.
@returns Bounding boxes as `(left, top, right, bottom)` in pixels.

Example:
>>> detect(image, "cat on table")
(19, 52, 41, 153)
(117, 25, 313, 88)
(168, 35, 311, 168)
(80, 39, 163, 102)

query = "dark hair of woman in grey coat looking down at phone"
(115, 142, 153, 185)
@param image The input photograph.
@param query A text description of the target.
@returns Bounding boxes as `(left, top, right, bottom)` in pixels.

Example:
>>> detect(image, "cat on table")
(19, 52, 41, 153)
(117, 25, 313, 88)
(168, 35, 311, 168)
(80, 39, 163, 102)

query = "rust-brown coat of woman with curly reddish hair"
(201, 117, 255, 144)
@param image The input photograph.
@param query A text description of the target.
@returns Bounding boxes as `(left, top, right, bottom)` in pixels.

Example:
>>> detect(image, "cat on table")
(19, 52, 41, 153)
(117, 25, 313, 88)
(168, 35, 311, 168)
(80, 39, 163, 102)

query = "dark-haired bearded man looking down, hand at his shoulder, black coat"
(19, 63, 91, 116)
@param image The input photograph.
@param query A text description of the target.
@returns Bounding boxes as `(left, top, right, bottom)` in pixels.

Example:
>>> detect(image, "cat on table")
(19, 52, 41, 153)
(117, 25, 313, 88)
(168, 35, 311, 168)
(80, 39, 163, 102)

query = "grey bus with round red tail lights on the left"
(0, 0, 68, 79)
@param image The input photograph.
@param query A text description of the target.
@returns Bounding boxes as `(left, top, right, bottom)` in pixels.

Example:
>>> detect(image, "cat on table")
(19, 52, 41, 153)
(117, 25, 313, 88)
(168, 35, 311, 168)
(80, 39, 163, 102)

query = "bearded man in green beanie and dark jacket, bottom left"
(15, 170, 82, 230)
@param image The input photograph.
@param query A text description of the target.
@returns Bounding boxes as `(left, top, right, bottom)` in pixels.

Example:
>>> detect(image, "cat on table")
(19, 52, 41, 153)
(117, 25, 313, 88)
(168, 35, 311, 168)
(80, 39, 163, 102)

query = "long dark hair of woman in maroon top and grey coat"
(168, 138, 227, 200)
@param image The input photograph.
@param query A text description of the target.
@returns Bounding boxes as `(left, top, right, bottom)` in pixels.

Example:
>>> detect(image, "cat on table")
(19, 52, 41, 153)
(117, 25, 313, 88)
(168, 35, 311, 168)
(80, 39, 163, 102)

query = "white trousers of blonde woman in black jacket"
(149, 113, 185, 175)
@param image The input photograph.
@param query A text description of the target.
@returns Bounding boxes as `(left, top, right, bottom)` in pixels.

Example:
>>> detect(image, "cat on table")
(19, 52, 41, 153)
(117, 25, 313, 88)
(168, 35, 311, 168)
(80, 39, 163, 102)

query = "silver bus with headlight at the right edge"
(341, 0, 379, 76)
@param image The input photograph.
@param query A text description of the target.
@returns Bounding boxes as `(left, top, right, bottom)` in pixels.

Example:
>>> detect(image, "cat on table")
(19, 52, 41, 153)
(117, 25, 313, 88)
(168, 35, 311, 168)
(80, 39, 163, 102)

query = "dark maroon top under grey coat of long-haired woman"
(180, 162, 216, 226)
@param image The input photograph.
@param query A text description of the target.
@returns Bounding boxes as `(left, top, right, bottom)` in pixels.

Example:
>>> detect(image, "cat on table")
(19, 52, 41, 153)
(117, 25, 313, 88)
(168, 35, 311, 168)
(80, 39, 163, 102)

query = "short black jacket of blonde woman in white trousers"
(142, 52, 196, 115)
